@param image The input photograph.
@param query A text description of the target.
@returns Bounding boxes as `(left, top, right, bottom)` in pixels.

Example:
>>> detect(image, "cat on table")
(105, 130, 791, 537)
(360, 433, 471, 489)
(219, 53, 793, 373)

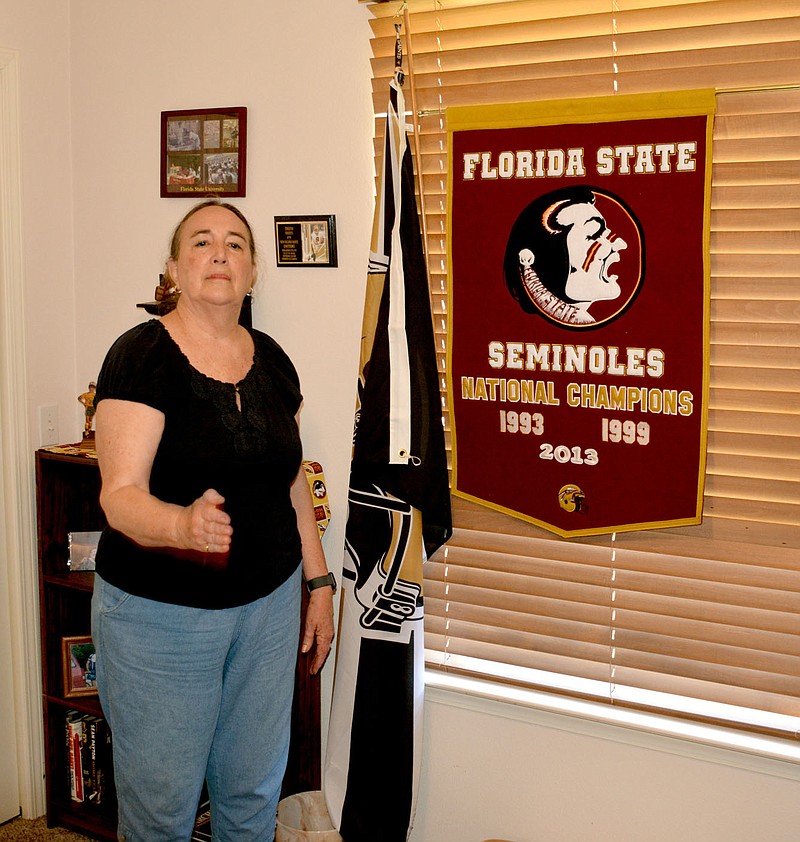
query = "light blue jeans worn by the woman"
(92, 567, 300, 842)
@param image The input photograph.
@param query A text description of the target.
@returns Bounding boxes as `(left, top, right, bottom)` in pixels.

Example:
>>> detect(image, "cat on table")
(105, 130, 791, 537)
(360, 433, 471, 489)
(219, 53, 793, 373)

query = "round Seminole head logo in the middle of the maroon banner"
(504, 186, 644, 329)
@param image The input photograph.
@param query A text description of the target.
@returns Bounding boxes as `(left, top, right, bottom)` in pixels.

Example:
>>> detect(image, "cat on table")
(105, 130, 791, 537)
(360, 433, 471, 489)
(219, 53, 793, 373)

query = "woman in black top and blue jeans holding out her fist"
(92, 200, 335, 842)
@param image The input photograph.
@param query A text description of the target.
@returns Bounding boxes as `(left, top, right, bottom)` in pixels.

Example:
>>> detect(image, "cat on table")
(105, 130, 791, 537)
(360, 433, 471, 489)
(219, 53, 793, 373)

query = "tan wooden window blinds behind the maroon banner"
(370, 0, 800, 738)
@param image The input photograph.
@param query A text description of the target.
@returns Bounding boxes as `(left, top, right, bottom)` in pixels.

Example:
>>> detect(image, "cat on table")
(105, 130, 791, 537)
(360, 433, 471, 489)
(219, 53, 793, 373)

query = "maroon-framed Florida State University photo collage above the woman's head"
(161, 108, 247, 198)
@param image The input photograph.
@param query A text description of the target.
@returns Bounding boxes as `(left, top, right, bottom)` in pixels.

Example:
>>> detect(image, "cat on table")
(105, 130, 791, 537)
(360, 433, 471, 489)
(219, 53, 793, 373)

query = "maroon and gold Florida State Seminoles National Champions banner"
(447, 91, 714, 536)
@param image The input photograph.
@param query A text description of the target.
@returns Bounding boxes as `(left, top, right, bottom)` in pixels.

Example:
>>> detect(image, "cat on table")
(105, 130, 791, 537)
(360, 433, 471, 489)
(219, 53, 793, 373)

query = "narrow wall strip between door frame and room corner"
(0, 0, 80, 446)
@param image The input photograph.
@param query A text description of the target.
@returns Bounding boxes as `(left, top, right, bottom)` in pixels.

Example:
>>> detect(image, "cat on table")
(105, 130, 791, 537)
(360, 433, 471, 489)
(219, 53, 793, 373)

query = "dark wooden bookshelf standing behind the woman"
(36, 446, 321, 840)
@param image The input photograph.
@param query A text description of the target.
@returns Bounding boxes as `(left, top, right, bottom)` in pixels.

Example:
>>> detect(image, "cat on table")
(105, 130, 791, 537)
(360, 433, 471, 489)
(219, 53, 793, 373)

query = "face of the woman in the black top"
(168, 206, 256, 305)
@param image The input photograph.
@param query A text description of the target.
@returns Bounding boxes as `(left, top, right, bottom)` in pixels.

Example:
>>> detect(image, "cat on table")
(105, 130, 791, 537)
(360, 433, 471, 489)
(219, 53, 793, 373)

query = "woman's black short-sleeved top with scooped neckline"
(97, 319, 302, 608)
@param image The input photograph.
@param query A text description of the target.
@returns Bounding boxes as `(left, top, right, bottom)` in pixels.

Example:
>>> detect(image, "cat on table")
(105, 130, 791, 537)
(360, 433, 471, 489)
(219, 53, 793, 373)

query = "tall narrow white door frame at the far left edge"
(0, 44, 45, 818)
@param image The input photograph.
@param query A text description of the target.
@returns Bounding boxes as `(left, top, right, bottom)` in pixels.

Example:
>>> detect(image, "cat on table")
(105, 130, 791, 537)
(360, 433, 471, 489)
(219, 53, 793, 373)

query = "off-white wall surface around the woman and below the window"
(6, 0, 800, 842)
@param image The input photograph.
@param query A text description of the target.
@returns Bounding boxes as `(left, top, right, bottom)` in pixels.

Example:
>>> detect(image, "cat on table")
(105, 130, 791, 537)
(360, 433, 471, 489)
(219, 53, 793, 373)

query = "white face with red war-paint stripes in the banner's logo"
(556, 204, 627, 301)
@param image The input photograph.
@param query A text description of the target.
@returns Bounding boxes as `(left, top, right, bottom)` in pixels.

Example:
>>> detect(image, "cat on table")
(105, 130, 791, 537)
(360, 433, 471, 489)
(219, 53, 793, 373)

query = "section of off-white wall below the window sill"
(412, 689, 800, 842)
